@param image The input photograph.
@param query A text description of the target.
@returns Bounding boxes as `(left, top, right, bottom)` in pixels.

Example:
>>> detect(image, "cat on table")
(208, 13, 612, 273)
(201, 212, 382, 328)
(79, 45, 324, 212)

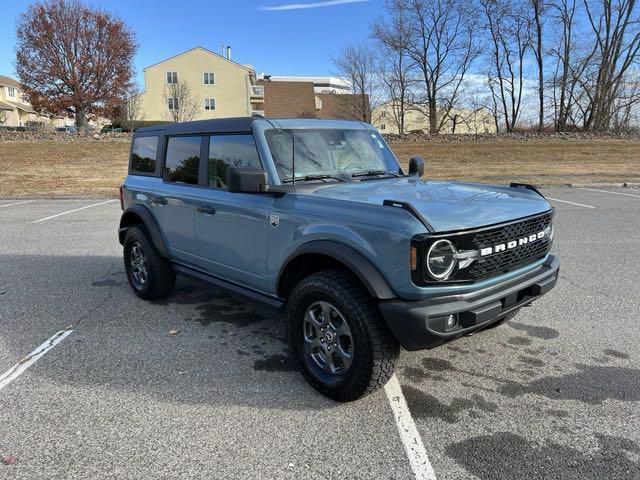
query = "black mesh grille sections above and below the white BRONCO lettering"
(468, 213, 552, 280)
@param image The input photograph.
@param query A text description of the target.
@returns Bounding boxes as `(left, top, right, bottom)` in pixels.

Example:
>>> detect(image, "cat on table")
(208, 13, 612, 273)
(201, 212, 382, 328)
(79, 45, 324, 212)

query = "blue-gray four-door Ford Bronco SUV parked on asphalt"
(119, 117, 559, 401)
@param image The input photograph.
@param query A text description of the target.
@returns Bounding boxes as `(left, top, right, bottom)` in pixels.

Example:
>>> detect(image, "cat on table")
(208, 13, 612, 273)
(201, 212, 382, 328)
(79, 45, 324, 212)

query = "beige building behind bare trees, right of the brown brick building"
(372, 102, 496, 134)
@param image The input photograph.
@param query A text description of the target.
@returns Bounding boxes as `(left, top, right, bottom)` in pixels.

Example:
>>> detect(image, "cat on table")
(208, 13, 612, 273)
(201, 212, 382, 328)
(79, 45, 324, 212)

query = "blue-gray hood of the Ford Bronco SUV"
(305, 177, 551, 232)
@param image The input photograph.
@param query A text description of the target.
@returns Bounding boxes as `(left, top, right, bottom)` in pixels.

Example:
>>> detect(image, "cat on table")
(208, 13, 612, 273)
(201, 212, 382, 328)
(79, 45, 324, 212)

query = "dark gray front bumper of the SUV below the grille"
(380, 255, 560, 350)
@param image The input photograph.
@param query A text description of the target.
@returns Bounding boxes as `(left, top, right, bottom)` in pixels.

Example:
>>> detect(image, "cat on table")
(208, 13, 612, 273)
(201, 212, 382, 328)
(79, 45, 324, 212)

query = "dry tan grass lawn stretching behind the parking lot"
(0, 140, 640, 198)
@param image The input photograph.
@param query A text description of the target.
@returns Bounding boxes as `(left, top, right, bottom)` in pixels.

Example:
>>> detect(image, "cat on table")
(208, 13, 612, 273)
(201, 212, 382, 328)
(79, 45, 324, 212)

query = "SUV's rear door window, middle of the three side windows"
(165, 136, 202, 185)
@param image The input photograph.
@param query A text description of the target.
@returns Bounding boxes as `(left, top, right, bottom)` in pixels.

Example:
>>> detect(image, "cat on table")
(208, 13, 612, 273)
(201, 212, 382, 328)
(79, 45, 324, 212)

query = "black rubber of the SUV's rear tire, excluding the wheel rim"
(124, 225, 176, 300)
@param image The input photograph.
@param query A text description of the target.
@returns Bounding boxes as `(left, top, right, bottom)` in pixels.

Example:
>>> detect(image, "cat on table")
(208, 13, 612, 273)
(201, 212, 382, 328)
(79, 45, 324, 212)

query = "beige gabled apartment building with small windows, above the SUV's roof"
(138, 47, 264, 121)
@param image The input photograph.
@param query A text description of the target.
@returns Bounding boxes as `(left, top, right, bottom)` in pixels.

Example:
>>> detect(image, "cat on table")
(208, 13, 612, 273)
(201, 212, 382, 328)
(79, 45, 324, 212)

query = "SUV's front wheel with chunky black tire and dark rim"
(287, 270, 400, 402)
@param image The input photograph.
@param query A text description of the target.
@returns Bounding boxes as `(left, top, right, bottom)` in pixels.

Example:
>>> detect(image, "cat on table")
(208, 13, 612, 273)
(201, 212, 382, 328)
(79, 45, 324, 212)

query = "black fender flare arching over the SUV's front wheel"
(276, 240, 398, 300)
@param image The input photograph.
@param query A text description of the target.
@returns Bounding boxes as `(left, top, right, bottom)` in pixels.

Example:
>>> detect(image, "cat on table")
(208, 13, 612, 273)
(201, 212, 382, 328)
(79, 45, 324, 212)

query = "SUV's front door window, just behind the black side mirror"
(207, 135, 262, 188)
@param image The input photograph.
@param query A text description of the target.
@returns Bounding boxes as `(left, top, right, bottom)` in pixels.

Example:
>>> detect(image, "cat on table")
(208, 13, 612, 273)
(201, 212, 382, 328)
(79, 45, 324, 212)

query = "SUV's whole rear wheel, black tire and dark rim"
(124, 225, 176, 300)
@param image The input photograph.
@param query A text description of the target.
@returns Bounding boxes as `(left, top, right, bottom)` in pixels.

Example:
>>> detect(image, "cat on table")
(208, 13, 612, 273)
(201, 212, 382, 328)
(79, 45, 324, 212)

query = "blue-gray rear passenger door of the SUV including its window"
(150, 135, 204, 265)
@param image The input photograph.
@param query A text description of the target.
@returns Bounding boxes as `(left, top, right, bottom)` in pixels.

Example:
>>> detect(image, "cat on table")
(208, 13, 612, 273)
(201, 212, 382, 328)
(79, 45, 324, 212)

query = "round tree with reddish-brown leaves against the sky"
(16, 0, 137, 130)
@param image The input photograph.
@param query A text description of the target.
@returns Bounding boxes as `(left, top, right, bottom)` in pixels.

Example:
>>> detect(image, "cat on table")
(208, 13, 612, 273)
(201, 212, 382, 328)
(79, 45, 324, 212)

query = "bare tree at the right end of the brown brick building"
(332, 42, 376, 122)
